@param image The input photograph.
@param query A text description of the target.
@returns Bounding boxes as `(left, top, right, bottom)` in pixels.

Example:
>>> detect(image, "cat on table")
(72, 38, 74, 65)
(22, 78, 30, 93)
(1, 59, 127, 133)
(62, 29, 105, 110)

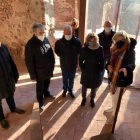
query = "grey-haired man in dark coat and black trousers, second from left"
(25, 23, 55, 109)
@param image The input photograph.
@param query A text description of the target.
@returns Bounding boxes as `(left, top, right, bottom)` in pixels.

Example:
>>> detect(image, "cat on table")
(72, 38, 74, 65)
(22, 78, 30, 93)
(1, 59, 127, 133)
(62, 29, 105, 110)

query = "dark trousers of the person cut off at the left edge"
(0, 96, 16, 121)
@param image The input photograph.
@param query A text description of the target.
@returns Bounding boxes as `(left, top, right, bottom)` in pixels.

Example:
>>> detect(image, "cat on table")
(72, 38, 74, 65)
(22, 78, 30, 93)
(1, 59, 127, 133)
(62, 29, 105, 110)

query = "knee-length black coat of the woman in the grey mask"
(79, 45, 104, 89)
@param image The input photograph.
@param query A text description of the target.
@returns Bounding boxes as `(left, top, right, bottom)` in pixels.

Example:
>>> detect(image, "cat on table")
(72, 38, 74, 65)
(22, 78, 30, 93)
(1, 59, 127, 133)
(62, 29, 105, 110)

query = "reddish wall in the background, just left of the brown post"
(54, 0, 80, 29)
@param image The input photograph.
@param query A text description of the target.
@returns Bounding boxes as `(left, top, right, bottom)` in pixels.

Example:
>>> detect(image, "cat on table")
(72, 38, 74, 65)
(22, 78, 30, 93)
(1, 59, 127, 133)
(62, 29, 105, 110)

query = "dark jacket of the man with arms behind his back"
(55, 36, 82, 71)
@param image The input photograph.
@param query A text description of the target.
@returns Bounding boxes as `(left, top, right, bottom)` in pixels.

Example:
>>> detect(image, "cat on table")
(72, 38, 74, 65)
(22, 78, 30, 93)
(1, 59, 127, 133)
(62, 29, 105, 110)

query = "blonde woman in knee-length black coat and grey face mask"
(79, 32, 104, 107)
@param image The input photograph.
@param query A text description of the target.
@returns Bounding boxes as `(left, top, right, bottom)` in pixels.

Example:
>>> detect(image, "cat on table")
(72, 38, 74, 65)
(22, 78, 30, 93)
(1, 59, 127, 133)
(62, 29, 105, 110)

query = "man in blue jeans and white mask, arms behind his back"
(55, 25, 82, 98)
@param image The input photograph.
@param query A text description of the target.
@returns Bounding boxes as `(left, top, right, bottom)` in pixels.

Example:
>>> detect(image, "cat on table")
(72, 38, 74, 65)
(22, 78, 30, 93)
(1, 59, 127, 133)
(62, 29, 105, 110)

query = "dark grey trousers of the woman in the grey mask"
(82, 86, 98, 99)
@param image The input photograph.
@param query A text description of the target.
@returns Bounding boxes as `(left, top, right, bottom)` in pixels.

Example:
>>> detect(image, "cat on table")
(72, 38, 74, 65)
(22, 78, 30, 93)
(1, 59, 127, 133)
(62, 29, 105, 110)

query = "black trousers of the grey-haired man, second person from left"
(36, 79, 50, 103)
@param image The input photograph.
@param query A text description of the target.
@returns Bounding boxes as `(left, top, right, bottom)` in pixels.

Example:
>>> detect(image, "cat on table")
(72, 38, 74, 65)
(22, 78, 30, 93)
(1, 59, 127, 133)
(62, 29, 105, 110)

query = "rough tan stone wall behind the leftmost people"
(0, 0, 45, 59)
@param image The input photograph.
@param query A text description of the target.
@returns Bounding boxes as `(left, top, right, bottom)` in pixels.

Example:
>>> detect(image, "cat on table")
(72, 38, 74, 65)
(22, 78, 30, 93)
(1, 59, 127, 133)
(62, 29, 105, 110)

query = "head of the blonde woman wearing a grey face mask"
(86, 32, 99, 47)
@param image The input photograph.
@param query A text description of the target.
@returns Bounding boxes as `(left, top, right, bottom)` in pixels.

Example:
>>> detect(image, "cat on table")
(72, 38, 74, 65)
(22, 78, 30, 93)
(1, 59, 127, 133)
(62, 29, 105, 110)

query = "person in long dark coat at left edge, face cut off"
(0, 43, 25, 129)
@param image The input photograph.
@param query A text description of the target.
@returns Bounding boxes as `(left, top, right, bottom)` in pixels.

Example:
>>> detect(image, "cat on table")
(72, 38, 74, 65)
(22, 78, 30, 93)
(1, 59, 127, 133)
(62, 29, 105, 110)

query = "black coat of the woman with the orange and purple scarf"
(105, 38, 137, 87)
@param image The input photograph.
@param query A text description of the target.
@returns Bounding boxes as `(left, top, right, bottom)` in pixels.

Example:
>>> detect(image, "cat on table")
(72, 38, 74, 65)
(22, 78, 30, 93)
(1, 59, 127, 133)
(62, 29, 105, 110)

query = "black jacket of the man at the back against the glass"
(98, 30, 115, 58)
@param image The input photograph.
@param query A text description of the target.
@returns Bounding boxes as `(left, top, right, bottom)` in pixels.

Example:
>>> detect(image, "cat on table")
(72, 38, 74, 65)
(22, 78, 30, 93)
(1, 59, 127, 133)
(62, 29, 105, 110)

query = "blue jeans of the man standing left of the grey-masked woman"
(62, 69, 76, 93)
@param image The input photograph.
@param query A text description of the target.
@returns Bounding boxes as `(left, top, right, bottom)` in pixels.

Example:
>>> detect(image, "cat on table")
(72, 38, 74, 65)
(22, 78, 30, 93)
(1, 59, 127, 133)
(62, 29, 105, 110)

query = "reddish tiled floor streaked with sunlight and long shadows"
(0, 60, 140, 140)
